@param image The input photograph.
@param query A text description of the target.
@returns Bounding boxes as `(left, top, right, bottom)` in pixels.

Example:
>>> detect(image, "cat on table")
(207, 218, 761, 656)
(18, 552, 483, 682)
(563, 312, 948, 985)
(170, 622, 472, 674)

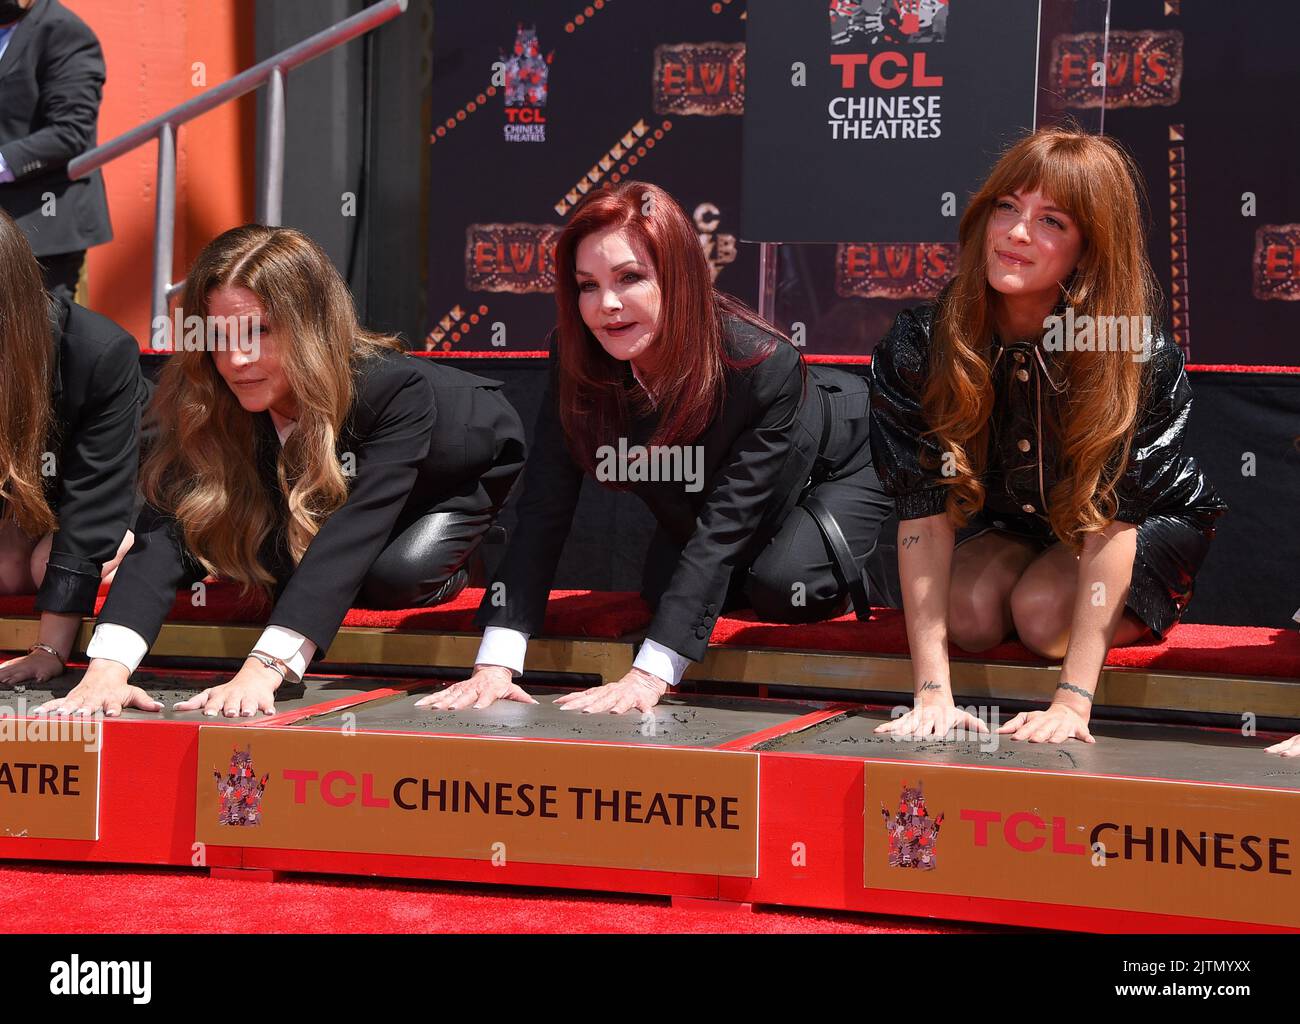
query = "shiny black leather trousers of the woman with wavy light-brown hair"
(355, 508, 497, 608)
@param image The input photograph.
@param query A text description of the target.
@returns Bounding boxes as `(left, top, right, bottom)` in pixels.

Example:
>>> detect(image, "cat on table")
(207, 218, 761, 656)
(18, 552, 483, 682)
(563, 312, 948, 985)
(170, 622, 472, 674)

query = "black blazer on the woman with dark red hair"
(476, 320, 821, 661)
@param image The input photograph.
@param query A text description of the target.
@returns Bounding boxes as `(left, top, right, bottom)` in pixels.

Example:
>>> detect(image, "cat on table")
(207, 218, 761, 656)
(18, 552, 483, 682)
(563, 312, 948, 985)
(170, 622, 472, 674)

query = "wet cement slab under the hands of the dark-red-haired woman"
(296, 686, 827, 747)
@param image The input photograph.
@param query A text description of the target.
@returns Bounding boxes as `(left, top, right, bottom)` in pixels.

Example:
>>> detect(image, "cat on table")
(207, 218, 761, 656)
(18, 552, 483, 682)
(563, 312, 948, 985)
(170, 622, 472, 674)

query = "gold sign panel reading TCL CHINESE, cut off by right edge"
(863, 762, 1300, 927)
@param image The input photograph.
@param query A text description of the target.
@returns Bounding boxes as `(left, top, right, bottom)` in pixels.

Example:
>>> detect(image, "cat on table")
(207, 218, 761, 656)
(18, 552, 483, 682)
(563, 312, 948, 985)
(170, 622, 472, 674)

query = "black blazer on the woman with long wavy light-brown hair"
(99, 352, 524, 651)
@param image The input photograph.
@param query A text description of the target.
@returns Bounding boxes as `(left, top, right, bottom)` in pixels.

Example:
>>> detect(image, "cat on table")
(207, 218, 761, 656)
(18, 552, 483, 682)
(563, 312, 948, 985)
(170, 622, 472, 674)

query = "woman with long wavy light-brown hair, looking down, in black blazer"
(38, 225, 524, 716)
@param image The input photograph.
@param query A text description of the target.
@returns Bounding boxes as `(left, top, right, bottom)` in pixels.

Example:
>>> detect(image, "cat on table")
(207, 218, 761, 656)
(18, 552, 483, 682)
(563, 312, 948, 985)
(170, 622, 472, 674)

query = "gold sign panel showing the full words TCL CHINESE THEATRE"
(195, 726, 758, 877)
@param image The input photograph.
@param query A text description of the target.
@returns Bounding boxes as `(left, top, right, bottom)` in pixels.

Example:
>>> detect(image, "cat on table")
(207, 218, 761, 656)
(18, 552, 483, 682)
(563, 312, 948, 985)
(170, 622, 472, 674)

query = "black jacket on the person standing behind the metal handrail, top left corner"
(0, 0, 113, 256)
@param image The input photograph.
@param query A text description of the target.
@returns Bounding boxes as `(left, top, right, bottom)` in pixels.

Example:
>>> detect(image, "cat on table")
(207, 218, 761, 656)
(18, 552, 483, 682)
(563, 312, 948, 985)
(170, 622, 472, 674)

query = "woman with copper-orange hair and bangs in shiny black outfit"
(871, 129, 1226, 743)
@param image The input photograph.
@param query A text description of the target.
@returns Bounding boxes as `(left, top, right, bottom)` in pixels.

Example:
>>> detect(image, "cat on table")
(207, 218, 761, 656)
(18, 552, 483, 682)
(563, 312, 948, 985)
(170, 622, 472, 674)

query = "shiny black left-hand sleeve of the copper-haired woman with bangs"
(871, 309, 948, 520)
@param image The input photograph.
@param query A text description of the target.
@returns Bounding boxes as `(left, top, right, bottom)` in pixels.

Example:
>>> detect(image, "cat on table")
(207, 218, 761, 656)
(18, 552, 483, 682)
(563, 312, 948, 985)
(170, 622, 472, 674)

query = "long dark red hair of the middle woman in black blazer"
(555, 182, 789, 473)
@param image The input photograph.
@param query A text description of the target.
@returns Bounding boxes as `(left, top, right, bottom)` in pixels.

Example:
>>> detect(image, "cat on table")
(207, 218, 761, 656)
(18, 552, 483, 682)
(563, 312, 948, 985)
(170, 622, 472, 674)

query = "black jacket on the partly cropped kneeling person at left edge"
(36, 300, 148, 615)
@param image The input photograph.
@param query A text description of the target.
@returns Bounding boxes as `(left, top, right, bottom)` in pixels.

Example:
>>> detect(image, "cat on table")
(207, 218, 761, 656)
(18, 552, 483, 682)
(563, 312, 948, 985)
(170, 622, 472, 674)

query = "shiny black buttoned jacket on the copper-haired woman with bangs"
(871, 303, 1227, 528)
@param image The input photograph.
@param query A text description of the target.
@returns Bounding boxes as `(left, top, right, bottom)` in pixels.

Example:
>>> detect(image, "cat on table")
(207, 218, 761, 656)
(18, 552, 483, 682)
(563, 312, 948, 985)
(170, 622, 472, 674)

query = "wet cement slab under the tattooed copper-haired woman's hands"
(758, 711, 1300, 790)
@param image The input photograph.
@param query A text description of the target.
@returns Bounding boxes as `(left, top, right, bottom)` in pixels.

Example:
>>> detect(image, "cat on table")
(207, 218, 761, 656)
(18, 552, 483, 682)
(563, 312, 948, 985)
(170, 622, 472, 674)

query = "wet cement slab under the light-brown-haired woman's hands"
(0, 669, 393, 723)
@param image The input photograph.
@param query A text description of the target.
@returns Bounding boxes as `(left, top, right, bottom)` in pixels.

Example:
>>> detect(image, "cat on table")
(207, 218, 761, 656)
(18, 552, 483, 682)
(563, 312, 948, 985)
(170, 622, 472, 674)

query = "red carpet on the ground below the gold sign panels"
(0, 863, 1000, 934)
